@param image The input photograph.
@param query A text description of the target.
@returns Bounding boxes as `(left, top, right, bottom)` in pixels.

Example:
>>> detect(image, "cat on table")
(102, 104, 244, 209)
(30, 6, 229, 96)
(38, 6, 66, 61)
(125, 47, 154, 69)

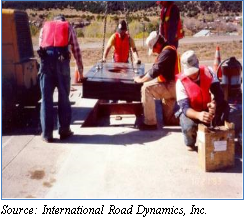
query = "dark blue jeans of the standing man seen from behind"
(39, 55, 71, 138)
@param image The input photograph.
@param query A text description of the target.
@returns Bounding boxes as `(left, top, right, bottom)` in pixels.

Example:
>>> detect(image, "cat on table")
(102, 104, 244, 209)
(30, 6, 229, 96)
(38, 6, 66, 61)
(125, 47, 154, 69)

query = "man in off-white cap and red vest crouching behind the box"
(176, 50, 229, 150)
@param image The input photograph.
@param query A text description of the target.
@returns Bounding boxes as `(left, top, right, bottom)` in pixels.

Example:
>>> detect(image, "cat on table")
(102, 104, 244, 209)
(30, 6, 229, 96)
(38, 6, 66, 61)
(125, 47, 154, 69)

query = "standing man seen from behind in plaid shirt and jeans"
(38, 15, 83, 142)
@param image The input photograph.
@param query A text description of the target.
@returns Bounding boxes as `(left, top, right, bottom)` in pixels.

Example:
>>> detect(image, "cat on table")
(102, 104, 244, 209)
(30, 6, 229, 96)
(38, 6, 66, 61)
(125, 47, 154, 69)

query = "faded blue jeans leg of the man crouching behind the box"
(180, 113, 198, 146)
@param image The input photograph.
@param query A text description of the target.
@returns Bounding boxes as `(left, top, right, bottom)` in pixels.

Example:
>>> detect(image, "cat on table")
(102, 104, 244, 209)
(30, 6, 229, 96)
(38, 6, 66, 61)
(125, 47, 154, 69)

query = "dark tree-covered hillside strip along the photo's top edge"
(2, 1, 243, 14)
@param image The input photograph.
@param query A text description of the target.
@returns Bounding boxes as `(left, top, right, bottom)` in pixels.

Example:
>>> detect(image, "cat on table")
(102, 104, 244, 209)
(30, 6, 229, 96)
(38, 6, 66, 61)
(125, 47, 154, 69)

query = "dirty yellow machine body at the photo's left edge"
(2, 9, 40, 123)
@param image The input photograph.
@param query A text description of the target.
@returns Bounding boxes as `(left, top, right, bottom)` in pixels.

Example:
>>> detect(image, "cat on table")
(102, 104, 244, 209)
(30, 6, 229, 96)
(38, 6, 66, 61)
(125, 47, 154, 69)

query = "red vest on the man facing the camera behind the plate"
(114, 33, 130, 63)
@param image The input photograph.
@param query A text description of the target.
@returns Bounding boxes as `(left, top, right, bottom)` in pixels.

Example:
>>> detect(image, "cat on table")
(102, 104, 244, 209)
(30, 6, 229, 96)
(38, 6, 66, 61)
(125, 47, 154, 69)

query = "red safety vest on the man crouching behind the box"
(179, 66, 213, 112)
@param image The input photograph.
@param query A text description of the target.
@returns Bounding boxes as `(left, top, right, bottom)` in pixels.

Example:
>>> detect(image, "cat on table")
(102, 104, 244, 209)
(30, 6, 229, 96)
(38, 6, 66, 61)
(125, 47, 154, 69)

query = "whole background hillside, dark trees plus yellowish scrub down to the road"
(3, 1, 243, 38)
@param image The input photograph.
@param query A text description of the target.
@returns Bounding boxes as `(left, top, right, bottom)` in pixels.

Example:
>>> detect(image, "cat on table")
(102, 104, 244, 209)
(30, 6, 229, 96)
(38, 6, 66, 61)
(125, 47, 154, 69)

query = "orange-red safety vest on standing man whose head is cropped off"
(161, 4, 184, 41)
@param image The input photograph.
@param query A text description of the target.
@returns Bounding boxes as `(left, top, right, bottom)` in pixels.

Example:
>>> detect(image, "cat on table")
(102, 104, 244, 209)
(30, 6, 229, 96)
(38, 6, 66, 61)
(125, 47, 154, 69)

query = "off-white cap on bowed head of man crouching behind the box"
(181, 50, 199, 76)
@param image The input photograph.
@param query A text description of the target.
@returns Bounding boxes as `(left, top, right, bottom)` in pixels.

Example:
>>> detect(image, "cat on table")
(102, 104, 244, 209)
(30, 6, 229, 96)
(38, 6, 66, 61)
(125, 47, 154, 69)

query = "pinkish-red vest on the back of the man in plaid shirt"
(41, 21, 69, 48)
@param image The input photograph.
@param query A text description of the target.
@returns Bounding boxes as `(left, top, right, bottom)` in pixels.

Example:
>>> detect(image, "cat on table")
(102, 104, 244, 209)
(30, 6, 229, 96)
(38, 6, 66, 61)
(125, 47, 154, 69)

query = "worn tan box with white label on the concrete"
(197, 122, 235, 172)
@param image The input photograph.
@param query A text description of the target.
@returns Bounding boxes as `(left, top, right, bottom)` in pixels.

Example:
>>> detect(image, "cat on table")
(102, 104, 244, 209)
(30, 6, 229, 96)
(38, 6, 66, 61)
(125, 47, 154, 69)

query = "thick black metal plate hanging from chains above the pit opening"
(83, 63, 145, 101)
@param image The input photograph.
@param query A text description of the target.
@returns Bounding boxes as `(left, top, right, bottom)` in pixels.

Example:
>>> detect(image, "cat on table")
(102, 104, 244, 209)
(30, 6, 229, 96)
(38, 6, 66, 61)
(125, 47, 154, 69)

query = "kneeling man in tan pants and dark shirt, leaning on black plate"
(134, 31, 178, 130)
